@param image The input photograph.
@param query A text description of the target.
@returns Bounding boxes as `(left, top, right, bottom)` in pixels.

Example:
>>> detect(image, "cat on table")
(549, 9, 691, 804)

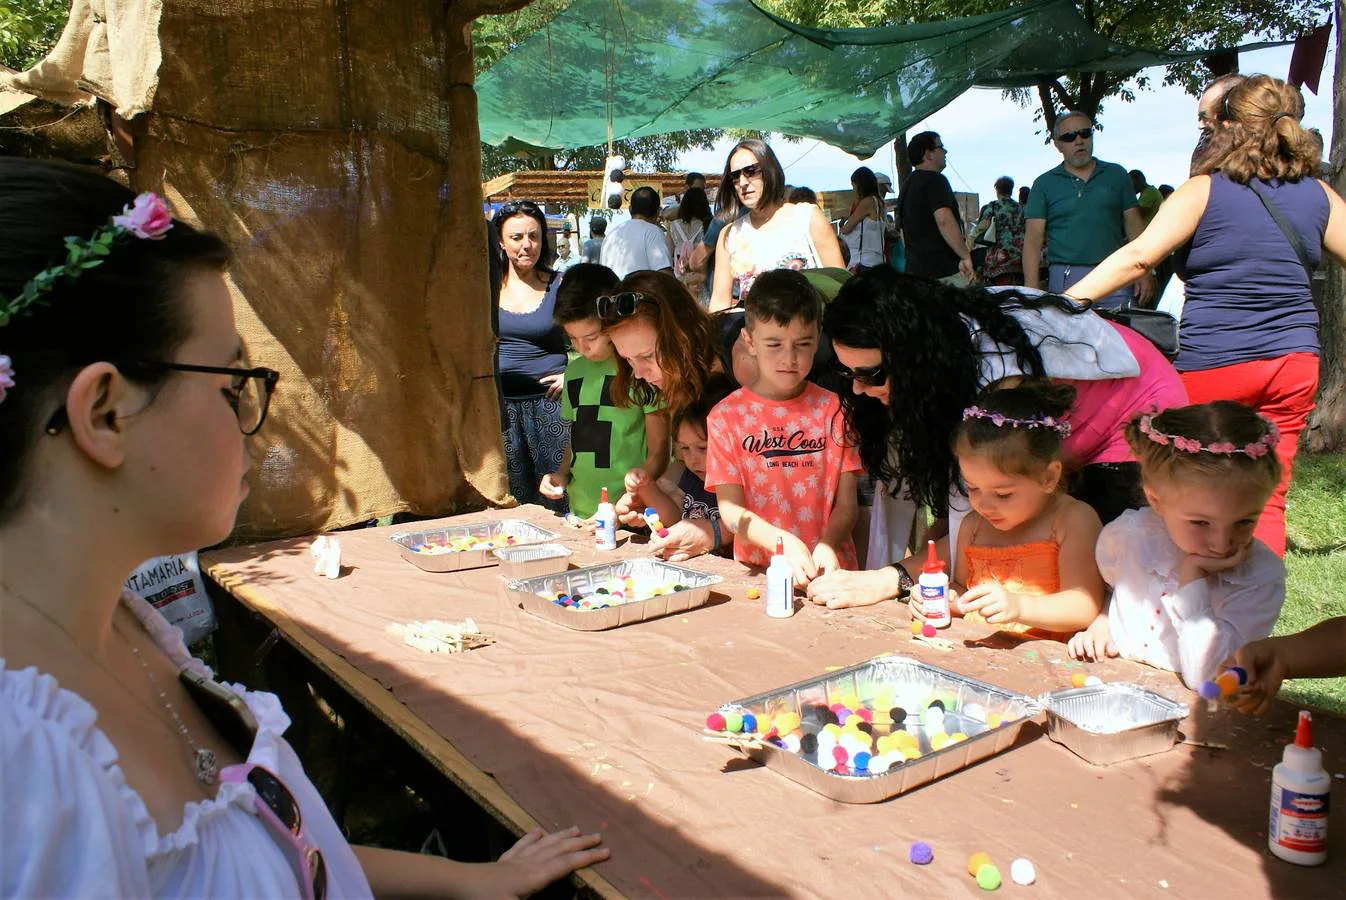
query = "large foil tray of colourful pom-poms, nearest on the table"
(721, 657, 1039, 803)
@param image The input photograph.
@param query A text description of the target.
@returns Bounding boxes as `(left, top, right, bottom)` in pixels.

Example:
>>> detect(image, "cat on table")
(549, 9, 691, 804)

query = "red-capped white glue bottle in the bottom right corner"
(1267, 710, 1333, 865)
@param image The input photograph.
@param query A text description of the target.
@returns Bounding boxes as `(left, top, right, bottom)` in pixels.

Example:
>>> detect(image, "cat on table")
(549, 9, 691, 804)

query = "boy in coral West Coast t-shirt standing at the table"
(705, 269, 863, 587)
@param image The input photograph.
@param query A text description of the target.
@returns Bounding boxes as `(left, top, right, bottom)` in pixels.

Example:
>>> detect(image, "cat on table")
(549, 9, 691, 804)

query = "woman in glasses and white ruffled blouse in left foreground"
(0, 157, 606, 897)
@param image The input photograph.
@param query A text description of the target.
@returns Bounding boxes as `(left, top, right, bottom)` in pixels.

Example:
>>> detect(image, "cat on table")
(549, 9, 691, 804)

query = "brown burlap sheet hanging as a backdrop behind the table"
(2, 0, 509, 538)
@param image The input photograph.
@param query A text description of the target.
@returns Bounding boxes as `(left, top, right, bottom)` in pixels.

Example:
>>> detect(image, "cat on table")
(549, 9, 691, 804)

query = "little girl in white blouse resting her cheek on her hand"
(1070, 400, 1285, 687)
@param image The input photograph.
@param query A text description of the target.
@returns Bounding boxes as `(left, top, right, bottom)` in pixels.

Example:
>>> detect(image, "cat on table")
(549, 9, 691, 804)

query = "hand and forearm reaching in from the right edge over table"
(1229, 616, 1346, 716)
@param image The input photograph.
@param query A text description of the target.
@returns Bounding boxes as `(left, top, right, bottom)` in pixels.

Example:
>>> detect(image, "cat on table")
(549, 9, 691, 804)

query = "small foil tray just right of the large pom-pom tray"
(1043, 683, 1190, 765)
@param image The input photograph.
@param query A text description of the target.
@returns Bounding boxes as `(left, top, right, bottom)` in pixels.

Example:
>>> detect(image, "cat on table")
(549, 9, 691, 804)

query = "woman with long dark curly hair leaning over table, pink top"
(809, 266, 1187, 607)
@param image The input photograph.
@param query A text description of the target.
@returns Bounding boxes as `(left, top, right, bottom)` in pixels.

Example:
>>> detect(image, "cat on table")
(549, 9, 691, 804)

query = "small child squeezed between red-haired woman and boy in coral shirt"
(627, 375, 734, 560)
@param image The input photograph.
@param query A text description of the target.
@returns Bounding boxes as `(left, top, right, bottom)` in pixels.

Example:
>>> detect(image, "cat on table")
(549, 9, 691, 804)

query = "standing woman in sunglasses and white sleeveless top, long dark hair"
(711, 140, 845, 312)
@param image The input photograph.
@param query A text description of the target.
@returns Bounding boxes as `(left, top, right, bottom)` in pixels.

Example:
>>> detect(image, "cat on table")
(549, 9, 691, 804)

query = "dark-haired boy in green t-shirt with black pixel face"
(538, 262, 669, 519)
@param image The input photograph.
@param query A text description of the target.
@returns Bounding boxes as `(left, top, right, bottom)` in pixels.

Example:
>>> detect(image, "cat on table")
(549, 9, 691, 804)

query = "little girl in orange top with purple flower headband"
(953, 381, 1104, 635)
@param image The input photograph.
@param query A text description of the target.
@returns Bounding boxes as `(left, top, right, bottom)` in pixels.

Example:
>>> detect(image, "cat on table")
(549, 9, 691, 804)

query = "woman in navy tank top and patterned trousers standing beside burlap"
(493, 200, 569, 511)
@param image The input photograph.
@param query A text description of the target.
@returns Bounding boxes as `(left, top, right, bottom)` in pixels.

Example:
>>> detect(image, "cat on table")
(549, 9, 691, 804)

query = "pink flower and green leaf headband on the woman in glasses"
(0, 191, 172, 402)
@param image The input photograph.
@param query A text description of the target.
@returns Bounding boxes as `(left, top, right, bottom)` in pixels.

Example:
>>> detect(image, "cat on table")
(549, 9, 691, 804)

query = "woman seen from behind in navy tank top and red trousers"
(1070, 75, 1346, 556)
